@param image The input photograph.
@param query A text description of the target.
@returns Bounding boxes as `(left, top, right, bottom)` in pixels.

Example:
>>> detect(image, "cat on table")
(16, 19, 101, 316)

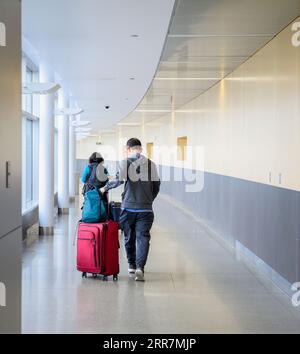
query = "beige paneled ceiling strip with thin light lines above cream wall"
(118, 0, 300, 125)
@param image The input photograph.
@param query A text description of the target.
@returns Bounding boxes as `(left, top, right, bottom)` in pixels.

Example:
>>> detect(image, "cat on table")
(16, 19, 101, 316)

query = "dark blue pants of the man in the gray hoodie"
(120, 210, 154, 269)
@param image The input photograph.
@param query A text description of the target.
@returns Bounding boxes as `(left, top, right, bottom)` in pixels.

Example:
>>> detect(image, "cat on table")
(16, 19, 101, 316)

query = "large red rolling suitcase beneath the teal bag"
(77, 221, 119, 280)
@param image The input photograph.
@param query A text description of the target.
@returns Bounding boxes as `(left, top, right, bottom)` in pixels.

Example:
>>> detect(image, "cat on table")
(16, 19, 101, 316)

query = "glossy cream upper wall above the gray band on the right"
(84, 18, 300, 190)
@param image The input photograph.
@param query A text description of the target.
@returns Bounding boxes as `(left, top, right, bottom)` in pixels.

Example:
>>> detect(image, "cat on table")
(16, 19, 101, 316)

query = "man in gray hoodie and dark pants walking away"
(101, 138, 160, 281)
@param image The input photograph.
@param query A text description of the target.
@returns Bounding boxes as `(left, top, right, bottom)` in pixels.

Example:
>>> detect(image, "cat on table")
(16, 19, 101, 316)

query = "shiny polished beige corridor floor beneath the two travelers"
(22, 199, 300, 333)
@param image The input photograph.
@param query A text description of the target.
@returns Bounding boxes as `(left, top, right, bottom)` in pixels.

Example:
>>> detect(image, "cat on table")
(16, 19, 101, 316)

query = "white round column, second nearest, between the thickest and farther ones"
(58, 89, 69, 214)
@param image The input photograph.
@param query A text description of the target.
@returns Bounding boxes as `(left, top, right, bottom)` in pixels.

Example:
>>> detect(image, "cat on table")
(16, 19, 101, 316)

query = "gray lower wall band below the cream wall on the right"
(160, 167, 300, 283)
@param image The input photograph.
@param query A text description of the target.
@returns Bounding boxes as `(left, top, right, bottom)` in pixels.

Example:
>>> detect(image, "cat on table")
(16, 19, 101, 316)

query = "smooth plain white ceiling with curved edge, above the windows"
(22, 0, 175, 132)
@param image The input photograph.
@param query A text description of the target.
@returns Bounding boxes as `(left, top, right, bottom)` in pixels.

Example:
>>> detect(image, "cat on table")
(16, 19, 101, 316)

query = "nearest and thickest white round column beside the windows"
(39, 62, 55, 235)
